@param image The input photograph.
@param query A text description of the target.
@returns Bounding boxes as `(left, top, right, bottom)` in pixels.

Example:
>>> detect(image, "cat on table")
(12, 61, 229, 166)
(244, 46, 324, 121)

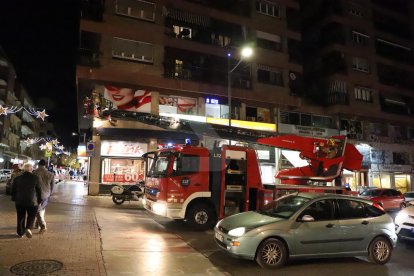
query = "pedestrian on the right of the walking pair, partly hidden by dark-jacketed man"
(33, 159, 55, 233)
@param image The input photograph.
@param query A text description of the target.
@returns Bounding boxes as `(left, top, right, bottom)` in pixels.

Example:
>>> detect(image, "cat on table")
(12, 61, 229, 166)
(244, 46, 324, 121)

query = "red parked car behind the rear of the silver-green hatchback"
(359, 188, 406, 210)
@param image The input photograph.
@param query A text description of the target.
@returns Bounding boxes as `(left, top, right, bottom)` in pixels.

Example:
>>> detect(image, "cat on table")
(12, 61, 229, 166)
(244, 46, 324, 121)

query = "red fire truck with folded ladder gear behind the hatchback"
(143, 136, 362, 229)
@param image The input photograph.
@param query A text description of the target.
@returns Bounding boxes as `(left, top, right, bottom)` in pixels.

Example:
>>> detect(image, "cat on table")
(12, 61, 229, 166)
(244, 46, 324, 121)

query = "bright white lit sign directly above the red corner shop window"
(101, 141, 147, 157)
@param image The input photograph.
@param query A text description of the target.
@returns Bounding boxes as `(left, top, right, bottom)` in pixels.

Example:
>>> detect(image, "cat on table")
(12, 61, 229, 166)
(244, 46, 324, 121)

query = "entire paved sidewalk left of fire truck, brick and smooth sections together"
(0, 181, 228, 276)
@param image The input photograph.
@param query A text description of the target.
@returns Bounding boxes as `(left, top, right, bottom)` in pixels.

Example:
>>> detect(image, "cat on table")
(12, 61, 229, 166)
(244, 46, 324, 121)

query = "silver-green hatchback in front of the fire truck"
(214, 193, 397, 268)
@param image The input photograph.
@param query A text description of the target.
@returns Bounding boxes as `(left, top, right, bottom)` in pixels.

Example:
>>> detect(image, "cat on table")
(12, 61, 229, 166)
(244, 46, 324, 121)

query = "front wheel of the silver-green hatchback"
(256, 238, 287, 268)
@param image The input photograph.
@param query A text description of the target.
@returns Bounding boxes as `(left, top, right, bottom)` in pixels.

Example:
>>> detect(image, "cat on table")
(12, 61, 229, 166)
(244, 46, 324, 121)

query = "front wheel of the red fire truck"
(186, 203, 214, 230)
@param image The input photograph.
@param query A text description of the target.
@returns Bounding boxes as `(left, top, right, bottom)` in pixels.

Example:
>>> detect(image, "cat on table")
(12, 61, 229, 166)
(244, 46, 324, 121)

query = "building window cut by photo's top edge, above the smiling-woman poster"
(115, 0, 155, 21)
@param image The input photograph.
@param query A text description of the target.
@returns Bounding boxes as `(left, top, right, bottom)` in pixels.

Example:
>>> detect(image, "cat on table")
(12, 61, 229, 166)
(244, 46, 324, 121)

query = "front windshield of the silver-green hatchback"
(258, 194, 310, 218)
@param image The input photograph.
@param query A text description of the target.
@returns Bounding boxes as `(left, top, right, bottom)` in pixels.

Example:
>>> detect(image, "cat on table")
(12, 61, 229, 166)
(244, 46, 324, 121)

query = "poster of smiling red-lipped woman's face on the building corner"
(104, 85, 151, 113)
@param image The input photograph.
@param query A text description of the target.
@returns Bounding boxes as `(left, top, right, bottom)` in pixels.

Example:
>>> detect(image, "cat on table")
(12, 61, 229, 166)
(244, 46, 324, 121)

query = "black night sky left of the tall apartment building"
(0, 0, 80, 150)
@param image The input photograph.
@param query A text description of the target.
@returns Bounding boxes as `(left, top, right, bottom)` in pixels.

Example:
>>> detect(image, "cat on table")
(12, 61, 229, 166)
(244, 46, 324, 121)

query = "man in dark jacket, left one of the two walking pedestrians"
(11, 163, 42, 238)
